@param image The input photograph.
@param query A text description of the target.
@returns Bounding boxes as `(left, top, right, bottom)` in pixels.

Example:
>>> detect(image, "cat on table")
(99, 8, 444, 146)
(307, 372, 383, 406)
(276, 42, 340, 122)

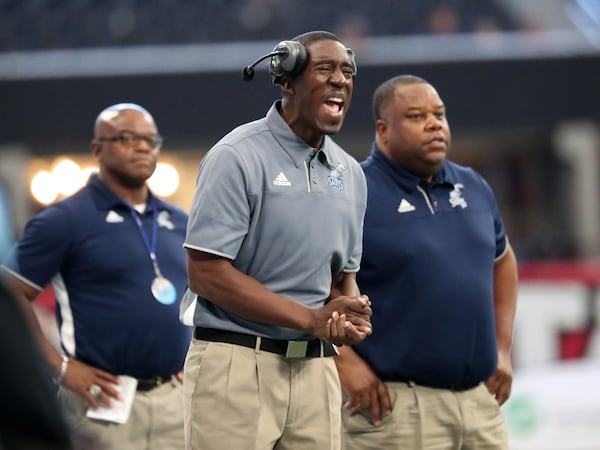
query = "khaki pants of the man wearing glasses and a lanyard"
(59, 377, 184, 450)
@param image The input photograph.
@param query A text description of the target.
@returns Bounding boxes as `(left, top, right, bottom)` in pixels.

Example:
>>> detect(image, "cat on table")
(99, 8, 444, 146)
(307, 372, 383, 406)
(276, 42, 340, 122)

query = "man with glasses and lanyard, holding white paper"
(4, 103, 191, 449)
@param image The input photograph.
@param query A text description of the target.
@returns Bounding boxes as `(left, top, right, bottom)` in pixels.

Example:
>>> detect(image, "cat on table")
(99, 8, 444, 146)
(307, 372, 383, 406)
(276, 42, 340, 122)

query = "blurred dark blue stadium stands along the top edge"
(0, 0, 520, 51)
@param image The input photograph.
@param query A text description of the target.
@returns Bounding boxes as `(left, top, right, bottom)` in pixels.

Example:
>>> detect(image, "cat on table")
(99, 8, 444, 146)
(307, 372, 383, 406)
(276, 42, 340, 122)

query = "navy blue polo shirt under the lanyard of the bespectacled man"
(4, 175, 191, 378)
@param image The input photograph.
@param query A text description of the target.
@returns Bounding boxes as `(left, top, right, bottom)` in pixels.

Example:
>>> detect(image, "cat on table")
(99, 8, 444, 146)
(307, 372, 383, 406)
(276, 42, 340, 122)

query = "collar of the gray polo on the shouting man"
(267, 100, 332, 167)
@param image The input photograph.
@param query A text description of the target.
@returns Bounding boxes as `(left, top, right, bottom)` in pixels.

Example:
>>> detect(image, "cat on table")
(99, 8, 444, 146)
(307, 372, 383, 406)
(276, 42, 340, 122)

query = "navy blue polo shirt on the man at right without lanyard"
(355, 146, 507, 387)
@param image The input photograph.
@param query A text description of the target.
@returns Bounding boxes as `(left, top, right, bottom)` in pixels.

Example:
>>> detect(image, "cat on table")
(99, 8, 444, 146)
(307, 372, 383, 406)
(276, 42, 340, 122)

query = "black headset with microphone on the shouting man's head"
(242, 41, 356, 84)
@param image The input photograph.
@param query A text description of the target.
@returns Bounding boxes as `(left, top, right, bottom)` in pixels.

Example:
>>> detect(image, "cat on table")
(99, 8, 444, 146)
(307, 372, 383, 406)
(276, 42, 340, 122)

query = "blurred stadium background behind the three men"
(0, 0, 600, 449)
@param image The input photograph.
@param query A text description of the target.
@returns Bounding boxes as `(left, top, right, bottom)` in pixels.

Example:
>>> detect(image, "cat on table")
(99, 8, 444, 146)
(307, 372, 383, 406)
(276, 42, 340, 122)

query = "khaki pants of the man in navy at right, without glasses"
(342, 383, 508, 450)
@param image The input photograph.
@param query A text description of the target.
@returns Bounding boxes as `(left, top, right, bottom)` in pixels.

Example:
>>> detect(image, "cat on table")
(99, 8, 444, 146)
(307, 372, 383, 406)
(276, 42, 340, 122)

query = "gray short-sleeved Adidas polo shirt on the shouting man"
(181, 101, 367, 339)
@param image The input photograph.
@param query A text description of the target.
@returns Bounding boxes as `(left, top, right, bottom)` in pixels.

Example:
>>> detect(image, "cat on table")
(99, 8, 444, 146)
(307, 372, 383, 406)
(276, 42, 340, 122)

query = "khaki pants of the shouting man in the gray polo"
(183, 339, 341, 450)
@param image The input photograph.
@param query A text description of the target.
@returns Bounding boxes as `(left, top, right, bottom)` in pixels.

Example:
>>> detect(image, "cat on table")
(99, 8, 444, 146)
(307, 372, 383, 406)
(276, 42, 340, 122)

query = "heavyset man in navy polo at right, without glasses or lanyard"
(336, 75, 517, 450)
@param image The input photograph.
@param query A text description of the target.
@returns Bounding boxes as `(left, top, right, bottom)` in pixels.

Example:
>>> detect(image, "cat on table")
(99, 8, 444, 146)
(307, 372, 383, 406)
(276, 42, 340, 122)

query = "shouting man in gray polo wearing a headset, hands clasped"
(182, 32, 371, 450)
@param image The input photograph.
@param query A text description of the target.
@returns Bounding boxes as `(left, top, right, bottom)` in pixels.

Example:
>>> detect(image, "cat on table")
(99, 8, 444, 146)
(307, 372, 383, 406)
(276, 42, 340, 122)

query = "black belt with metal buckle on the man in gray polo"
(194, 327, 338, 358)
